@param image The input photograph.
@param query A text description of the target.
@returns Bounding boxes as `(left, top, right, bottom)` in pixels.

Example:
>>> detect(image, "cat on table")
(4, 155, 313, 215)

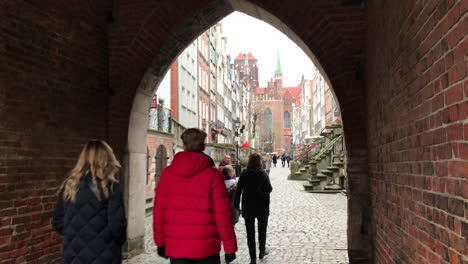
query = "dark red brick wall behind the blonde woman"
(0, 1, 108, 264)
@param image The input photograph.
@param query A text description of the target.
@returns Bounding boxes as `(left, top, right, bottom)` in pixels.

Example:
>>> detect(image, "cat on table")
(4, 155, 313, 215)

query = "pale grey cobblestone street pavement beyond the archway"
(124, 166, 349, 264)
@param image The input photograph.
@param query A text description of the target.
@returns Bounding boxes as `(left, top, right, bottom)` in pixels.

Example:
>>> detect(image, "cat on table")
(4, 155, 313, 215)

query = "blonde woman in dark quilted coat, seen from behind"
(52, 140, 127, 264)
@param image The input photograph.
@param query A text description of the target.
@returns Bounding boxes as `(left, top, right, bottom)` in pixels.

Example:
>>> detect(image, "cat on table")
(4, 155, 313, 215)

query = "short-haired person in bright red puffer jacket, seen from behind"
(153, 128, 237, 264)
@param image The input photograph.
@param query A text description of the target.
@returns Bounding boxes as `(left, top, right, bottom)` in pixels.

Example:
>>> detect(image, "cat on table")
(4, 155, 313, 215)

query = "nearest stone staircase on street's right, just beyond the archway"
(295, 125, 346, 193)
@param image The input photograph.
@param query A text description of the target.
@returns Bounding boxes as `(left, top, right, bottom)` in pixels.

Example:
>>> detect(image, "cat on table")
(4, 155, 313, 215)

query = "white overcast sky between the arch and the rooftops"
(221, 12, 314, 87)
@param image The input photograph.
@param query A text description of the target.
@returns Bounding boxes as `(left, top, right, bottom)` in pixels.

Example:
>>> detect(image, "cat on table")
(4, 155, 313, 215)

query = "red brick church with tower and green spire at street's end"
(234, 52, 301, 155)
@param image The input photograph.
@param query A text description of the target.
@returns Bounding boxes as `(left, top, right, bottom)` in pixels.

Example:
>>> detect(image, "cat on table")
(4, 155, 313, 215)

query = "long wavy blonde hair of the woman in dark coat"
(60, 140, 121, 201)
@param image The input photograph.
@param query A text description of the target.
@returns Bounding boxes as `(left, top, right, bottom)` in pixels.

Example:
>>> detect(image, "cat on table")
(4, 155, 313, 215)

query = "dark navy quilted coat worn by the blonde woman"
(52, 175, 127, 264)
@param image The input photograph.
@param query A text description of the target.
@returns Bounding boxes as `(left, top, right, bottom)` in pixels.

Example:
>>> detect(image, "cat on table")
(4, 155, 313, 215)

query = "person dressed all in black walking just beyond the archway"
(234, 153, 273, 264)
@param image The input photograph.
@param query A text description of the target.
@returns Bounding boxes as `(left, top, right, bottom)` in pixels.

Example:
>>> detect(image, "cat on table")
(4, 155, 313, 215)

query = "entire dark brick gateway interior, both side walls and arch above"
(0, 0, 468, 264)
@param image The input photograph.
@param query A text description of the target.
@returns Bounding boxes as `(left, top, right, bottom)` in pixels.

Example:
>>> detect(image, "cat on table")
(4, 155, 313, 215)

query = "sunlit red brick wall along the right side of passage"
(368, 0, 468, 263)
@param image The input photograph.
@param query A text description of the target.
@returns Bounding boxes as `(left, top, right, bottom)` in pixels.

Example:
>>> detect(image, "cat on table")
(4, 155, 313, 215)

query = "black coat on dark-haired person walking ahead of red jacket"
(234, 167, 273, 218)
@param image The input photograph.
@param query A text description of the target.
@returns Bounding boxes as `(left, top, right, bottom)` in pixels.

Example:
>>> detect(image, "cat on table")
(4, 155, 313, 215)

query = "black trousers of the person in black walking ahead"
(244, 215, 268, 259)
